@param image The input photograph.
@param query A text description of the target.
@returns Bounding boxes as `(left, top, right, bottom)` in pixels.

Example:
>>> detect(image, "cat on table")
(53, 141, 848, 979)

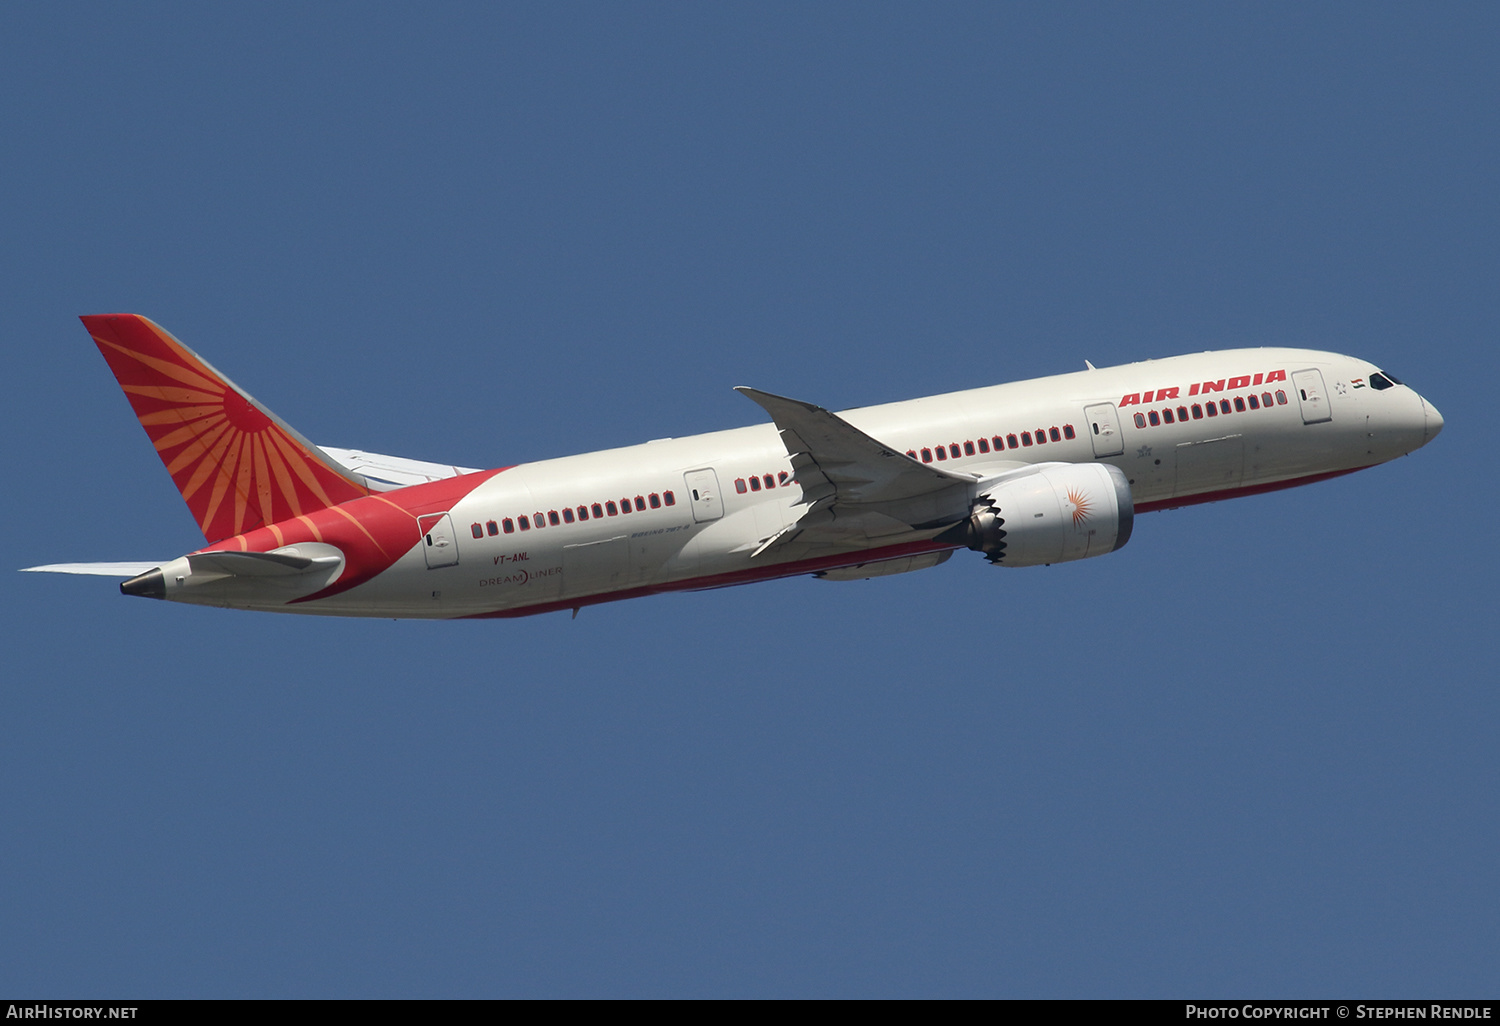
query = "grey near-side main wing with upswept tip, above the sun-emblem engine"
(735, 387, 975, 557)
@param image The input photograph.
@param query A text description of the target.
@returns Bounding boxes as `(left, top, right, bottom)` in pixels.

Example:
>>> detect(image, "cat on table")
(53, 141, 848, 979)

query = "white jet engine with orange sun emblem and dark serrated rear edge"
(966, 464, 1136, 567)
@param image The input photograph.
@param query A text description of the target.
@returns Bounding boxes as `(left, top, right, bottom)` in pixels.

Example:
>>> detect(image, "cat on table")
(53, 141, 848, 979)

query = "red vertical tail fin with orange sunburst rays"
(81, 314, 369, 543)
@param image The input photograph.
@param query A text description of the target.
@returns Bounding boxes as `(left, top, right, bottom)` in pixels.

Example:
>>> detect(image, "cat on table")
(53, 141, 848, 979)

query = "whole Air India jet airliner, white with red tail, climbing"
(20, 314, 1443, 618)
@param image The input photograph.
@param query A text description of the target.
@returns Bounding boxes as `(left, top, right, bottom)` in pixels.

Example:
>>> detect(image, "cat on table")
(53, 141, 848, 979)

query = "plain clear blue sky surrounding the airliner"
(0, 3, 1500, 998)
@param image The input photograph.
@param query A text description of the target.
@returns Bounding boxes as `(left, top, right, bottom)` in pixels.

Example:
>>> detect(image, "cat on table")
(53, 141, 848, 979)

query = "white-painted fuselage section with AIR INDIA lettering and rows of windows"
(208, 348, 1442, 617)
